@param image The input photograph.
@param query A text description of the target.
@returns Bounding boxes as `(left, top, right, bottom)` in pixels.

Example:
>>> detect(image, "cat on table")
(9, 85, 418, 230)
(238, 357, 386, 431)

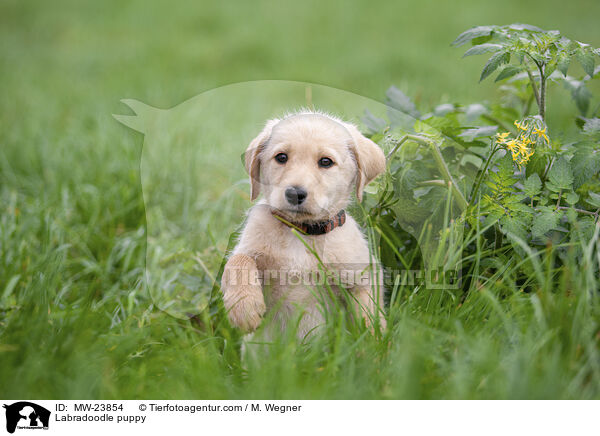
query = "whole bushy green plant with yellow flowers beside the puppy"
(364, 24, 600, 300)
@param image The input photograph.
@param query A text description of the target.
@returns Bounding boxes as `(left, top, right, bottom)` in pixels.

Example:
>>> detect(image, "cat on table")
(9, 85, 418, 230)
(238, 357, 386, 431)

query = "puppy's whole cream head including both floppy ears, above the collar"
(246, 113, 385, 222)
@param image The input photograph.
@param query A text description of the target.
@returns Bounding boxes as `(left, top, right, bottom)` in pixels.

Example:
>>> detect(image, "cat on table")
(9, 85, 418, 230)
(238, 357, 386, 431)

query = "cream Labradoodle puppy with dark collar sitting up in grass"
(221, 112, 385, 337)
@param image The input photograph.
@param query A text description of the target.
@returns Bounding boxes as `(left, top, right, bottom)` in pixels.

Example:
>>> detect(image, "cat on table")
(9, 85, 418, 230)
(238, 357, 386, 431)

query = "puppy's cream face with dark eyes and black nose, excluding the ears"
(260, 115, 356, 221)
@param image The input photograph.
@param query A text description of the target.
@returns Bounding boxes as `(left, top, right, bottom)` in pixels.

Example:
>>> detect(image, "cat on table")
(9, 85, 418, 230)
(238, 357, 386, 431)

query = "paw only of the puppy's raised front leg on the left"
(223, 285, 266, 333)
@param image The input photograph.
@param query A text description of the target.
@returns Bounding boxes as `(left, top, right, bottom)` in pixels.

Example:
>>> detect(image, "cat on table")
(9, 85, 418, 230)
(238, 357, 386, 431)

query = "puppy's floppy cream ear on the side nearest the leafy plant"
(344, 123, 385, 201)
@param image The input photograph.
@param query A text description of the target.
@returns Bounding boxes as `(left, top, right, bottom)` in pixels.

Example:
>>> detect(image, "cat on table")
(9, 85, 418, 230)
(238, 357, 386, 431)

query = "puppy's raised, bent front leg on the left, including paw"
(221, 254, 266, 332)
